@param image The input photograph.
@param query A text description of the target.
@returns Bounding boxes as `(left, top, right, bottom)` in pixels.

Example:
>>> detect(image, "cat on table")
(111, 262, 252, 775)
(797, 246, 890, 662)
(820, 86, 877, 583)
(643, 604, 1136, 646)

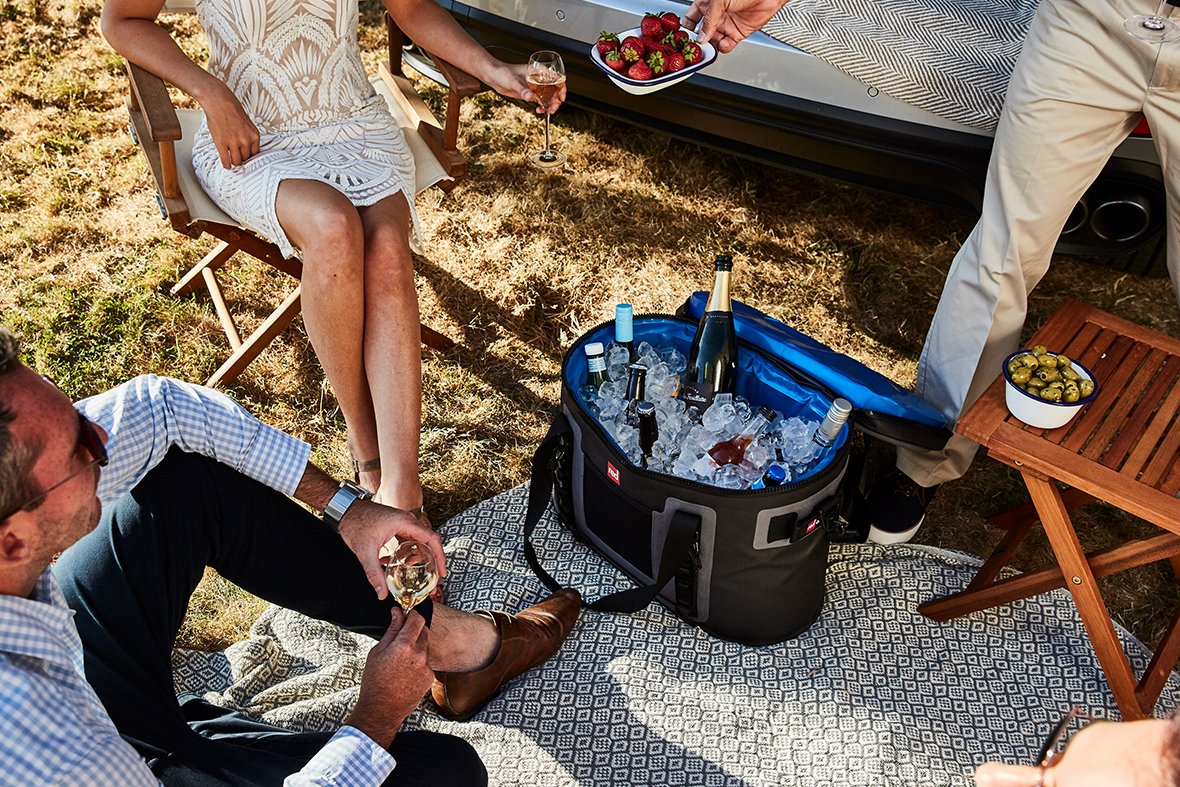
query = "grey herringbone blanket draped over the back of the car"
(762, 0, 1040, 131)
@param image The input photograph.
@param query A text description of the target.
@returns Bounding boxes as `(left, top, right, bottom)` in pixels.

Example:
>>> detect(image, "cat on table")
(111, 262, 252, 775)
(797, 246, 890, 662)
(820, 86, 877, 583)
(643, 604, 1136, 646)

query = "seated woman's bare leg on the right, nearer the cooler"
(359, 194, 422, 510)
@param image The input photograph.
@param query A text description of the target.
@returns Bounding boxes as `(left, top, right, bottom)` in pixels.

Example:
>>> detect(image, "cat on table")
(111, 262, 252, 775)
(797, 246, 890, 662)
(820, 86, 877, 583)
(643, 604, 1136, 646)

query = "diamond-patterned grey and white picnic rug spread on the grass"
(173, 487, 1180, 786)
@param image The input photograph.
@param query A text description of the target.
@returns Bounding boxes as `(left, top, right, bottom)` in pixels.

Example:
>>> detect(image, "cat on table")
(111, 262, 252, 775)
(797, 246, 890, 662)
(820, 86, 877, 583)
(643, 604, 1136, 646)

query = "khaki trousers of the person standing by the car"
(897, 0, 1180, 486)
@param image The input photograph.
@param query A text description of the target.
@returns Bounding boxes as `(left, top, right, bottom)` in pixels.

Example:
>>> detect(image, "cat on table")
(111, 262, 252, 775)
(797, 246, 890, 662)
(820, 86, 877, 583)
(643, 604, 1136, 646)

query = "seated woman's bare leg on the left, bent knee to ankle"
(275, 179, 381, 488)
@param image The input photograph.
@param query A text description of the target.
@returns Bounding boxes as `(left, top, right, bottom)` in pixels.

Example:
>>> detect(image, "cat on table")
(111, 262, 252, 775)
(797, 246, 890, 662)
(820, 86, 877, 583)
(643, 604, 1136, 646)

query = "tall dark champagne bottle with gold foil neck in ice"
(680, 254, 738, 414)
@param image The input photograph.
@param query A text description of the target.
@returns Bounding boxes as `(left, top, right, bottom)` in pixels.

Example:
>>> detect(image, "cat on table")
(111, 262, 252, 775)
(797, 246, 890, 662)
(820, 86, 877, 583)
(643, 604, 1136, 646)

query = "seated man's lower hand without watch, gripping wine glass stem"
(345, 606, 434, 748)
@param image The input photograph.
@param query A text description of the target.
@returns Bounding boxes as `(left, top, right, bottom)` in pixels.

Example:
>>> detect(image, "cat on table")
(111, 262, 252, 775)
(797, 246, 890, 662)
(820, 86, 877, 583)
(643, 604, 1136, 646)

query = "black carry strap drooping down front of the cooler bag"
(524, 413, 701, 612)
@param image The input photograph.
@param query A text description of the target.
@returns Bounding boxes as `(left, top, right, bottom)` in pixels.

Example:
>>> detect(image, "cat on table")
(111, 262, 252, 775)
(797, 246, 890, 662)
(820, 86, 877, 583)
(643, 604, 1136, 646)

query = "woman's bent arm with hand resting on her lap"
(103, 0, 260, 169)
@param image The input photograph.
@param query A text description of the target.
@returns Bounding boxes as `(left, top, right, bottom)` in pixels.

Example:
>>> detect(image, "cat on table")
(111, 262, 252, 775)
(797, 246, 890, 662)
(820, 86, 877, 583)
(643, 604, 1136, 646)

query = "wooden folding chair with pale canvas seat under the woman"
(126, 0, 484, 386)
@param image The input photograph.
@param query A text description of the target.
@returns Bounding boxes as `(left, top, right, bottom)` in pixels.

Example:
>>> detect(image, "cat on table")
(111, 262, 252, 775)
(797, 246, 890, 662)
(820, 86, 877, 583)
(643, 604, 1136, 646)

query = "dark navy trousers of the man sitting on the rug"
(53, 448, 487, 786)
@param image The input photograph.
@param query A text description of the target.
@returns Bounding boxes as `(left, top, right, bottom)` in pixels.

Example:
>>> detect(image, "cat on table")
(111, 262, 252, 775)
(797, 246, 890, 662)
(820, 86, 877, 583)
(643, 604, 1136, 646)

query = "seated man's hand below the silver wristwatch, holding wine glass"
(340, 500, 446, 598)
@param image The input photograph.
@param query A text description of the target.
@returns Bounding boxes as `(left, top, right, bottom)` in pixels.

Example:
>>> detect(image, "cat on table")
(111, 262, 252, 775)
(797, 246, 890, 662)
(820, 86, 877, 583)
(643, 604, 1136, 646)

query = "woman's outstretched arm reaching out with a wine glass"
(384, 0, 565, 112)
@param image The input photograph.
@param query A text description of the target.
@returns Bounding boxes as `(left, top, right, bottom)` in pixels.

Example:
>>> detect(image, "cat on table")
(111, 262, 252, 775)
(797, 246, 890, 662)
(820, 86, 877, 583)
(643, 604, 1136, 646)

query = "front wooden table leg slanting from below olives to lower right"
(1021, 471, 1151, 721)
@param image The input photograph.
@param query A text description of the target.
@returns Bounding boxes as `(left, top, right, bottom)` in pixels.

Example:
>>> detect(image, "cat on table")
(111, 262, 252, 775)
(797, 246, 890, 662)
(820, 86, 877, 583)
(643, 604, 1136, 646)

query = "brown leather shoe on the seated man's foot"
(431, 588, 582, 721)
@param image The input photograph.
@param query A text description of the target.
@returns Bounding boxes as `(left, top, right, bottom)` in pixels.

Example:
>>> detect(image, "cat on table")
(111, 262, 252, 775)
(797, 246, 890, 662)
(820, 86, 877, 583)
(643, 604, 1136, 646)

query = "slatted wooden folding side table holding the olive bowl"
(918, 301, 1180, 720)
